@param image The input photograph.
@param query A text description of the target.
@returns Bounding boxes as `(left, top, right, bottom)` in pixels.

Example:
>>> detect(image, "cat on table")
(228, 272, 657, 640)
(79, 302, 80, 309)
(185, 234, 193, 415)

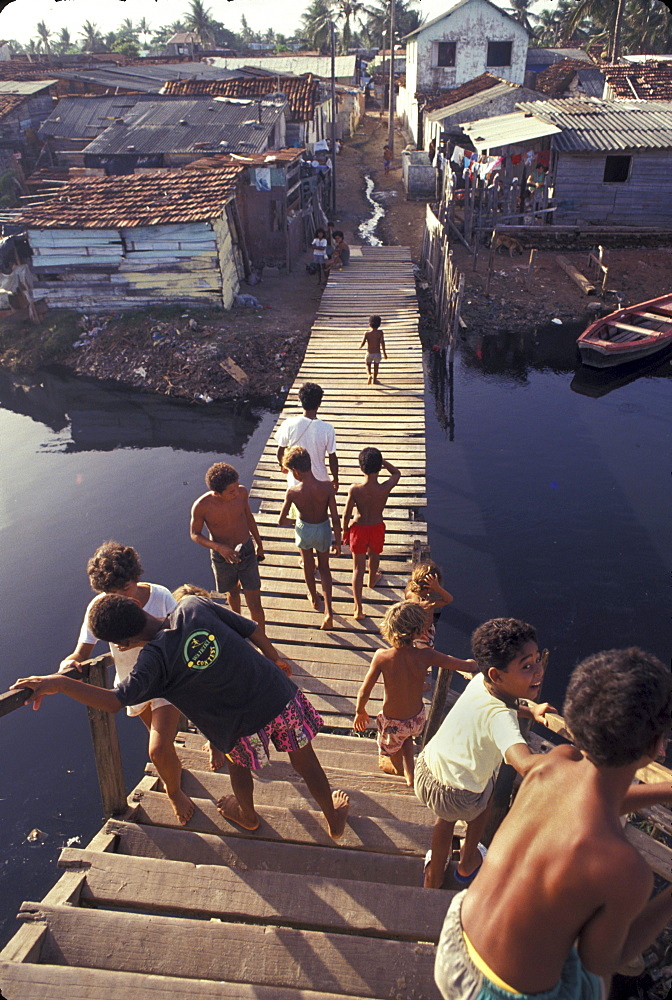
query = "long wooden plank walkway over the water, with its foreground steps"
(0, 247, 452, 1000)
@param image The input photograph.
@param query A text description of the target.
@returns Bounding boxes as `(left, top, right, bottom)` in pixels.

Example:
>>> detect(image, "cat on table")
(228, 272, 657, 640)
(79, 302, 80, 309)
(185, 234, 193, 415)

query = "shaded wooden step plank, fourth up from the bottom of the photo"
(105, 820, 428, 886)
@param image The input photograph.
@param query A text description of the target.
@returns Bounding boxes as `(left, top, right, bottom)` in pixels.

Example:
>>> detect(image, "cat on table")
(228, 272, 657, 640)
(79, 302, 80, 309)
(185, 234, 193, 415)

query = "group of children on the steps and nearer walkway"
(15, 372, 672, 1000)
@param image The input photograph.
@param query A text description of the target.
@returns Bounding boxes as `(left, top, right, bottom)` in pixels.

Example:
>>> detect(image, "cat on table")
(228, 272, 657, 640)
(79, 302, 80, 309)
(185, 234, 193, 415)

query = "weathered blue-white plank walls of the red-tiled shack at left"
(29, 222, 231, 311)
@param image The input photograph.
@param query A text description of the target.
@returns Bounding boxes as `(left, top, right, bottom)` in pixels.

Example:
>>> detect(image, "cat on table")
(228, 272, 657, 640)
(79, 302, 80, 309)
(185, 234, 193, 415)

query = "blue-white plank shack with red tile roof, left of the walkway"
(20, 163, 249, 311)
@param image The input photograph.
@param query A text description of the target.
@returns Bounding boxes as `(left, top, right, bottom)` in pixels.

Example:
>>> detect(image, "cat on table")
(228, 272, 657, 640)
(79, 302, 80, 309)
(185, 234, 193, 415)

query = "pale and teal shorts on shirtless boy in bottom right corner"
(434, 889, 604, 1000)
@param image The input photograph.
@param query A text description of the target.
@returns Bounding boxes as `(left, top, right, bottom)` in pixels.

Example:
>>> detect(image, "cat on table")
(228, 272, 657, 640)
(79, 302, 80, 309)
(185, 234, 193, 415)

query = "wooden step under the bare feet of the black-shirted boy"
(131, 790, 430, 852)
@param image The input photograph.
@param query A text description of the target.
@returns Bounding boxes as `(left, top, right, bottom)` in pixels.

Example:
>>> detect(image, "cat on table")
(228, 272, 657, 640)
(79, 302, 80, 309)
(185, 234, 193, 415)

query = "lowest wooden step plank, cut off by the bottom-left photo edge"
(0, 964, 368, 1000)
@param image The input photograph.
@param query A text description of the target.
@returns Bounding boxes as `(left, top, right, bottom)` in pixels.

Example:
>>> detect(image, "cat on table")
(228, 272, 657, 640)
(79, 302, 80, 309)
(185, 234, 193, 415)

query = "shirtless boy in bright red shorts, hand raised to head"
(343, 448, 401, 621)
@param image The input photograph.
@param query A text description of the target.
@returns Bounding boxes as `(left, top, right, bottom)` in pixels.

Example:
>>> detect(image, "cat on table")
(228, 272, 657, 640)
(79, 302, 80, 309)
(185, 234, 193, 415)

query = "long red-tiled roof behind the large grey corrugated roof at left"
(163, 73, 320, 122)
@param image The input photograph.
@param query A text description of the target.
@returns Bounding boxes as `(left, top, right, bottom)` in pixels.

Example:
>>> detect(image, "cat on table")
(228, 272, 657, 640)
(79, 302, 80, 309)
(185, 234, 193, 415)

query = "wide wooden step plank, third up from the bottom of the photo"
(58, 847, 446, 943)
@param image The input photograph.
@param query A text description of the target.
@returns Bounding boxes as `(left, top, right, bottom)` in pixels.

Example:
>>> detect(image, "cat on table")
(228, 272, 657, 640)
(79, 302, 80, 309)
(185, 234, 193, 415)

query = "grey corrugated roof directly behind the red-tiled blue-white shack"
(80, 96, 288, 174)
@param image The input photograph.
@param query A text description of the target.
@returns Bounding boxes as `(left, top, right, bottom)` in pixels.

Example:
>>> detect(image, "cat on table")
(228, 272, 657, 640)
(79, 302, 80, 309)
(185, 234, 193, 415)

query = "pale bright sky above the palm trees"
(0, 0, 516, 43)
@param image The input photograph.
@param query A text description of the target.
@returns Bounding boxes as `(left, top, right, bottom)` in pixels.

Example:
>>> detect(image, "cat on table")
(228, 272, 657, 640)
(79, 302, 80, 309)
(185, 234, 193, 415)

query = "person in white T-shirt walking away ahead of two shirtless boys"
(275, 382, 338, 493)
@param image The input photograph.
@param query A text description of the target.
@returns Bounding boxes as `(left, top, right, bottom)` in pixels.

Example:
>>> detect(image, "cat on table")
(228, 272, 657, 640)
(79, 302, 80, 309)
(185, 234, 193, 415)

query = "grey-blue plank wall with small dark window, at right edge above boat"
(553, 149, 672, 229)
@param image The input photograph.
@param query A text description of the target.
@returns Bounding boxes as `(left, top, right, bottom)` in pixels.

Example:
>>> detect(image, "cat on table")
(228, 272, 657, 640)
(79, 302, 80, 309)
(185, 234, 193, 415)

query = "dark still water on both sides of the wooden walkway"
(0, 326, 672, 944)
